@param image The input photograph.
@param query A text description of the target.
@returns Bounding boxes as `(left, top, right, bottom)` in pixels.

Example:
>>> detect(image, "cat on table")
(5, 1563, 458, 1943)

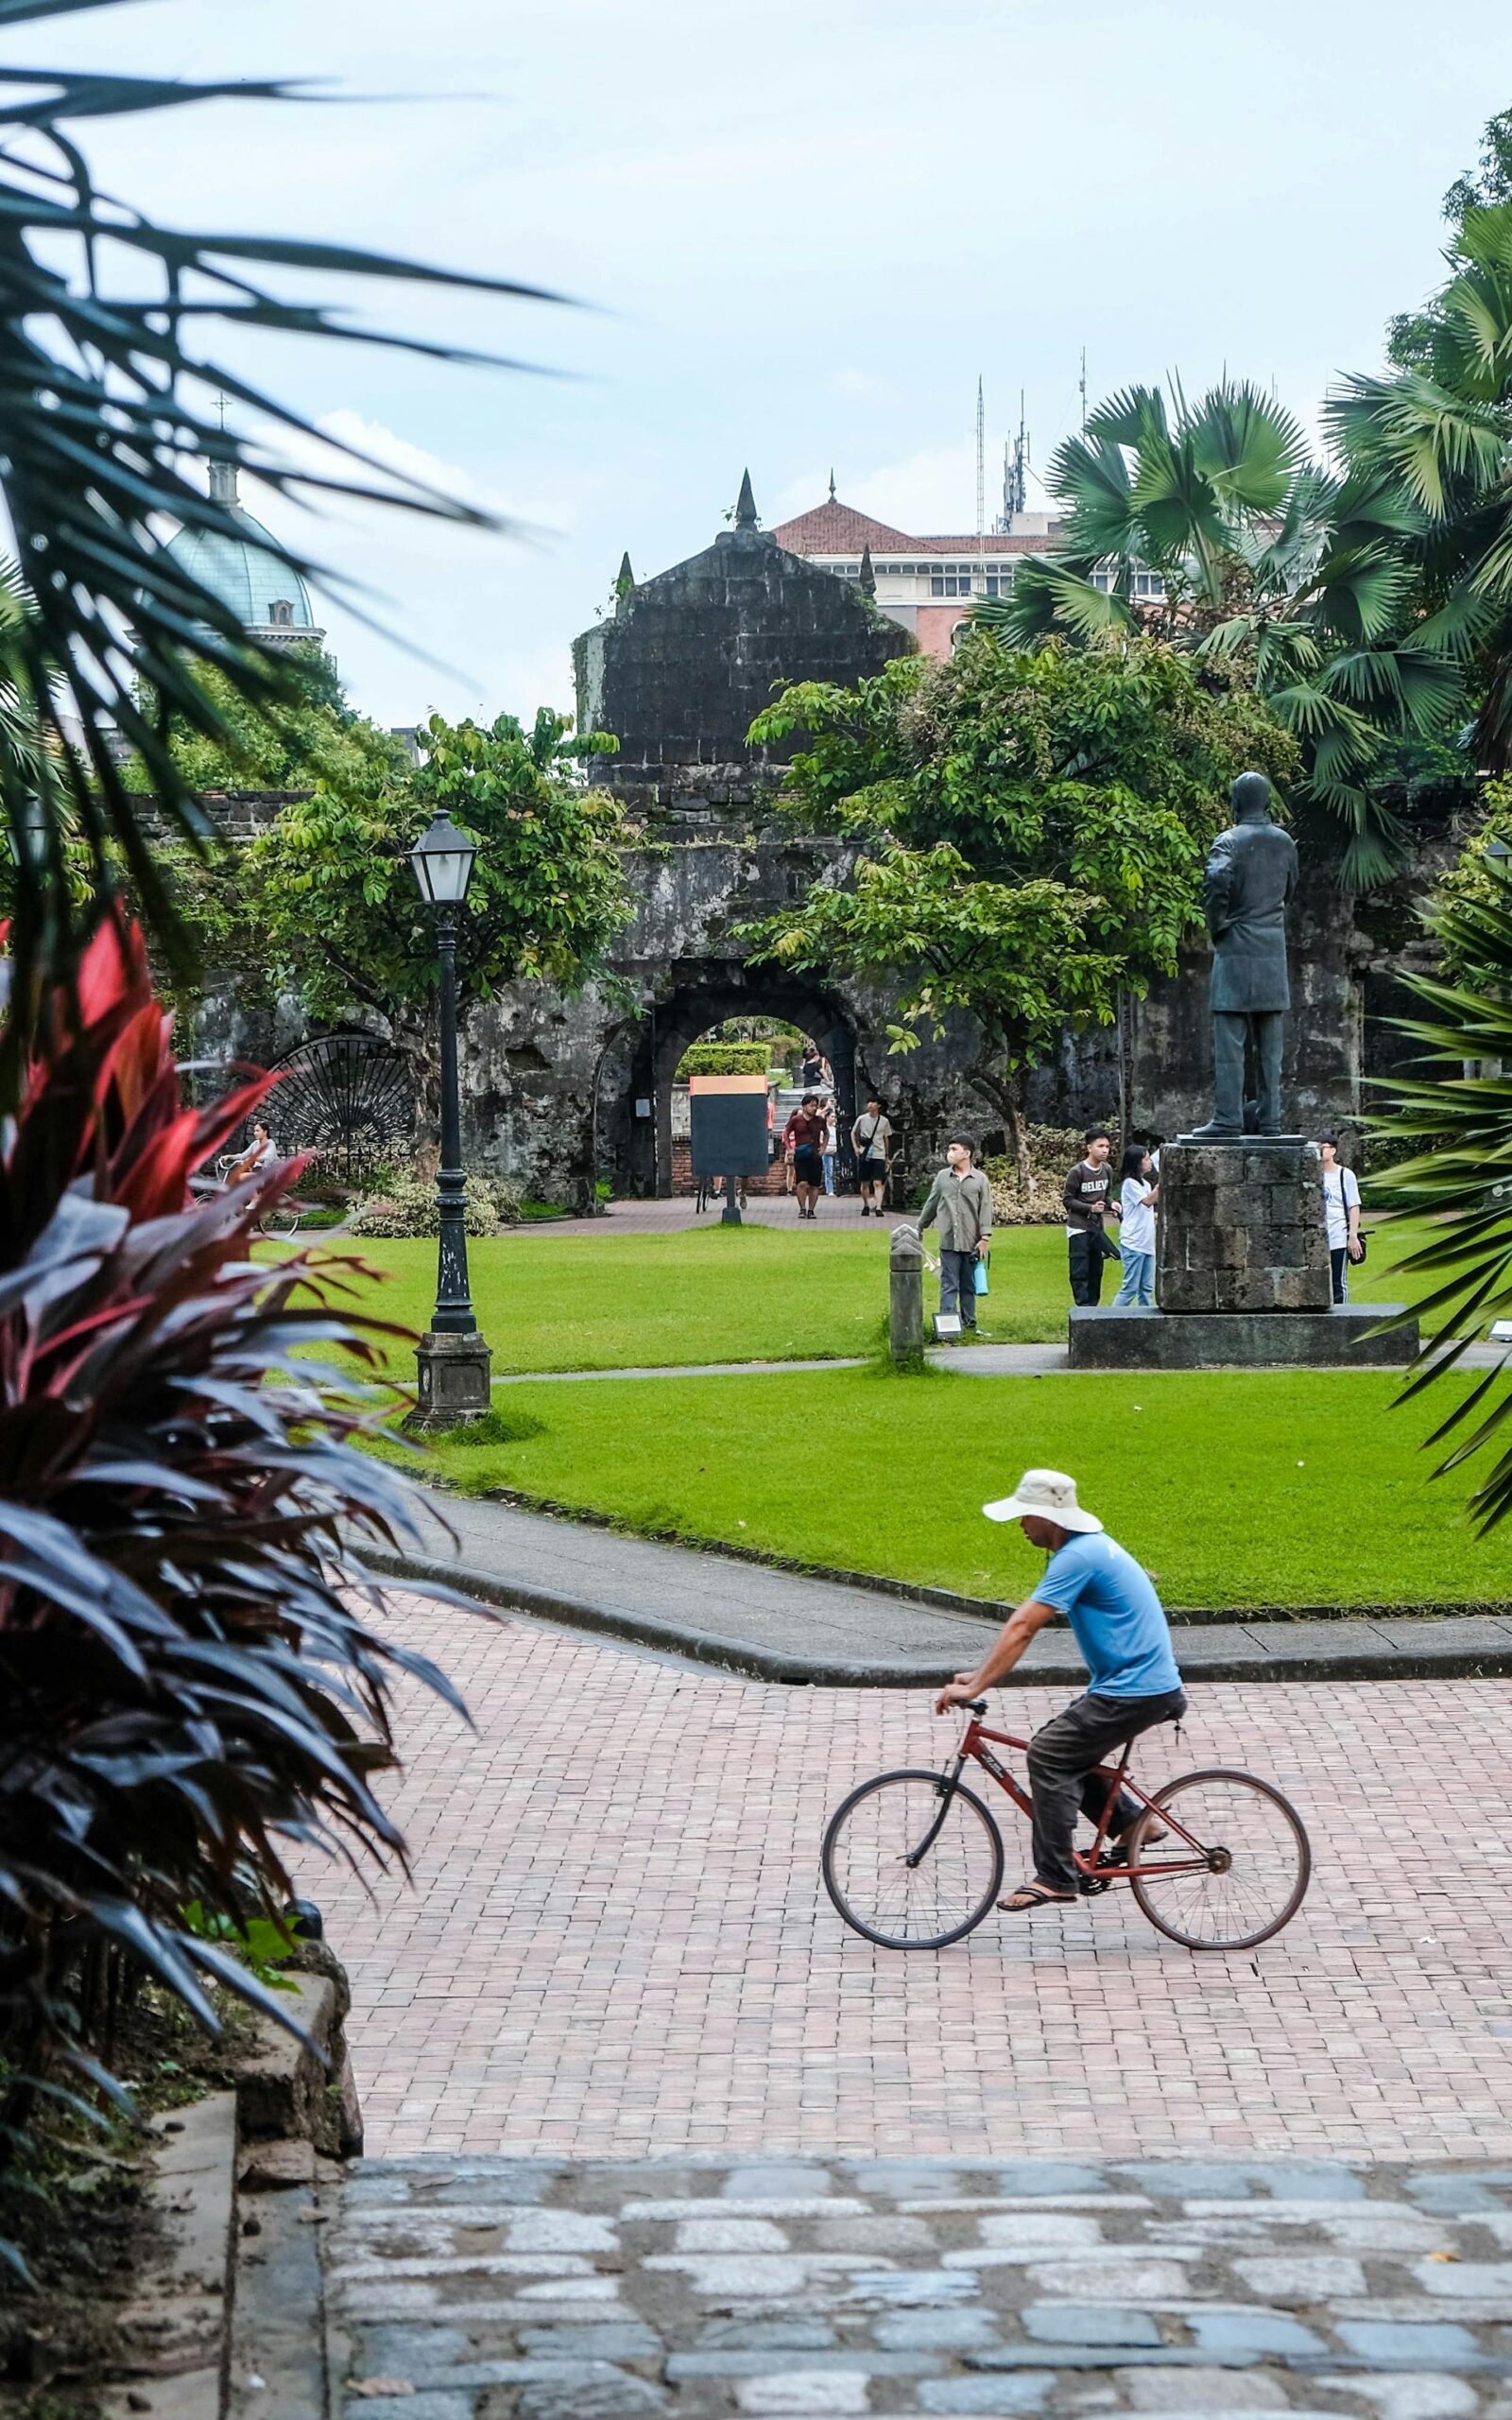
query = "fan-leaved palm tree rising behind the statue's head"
(972, 380, 1461, 889)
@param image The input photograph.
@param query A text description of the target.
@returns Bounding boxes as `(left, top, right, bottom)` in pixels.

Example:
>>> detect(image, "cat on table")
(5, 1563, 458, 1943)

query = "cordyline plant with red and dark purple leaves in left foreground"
(0, 922, 459, 2216)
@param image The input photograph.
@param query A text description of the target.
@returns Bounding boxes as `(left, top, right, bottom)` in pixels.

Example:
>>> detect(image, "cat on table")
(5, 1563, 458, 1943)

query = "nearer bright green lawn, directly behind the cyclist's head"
(421, 1370, 1512, 1607)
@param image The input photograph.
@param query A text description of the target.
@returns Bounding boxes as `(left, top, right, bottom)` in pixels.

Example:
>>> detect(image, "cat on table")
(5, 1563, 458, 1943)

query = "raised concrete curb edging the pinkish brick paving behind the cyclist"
(363, 1548, 1512, 1689)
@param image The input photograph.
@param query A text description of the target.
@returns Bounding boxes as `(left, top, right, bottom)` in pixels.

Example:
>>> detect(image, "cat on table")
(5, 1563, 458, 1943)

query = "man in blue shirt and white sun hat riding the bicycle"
(934, 1471, 1185, 1914)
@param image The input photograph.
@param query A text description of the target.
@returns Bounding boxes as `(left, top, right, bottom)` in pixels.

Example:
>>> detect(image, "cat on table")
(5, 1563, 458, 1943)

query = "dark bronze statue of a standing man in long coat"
(1191, 772, 1297, 1142)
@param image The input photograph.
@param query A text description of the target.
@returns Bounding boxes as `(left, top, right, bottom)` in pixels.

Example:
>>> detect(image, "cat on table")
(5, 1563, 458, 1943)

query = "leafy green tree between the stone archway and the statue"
(750, 631, 1297, 1154)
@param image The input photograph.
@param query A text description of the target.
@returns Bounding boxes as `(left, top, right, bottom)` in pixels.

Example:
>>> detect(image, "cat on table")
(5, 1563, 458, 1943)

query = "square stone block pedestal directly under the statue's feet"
(1154, 1137, 1333, 1312)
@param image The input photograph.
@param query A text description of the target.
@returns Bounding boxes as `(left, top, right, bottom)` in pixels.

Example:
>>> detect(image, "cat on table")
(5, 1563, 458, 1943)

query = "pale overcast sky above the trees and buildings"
(20, 0, 1512, 723)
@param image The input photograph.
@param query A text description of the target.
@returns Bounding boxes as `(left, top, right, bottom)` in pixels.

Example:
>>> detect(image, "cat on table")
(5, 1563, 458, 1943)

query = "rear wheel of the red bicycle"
(1130, 1767, 1314, 1950)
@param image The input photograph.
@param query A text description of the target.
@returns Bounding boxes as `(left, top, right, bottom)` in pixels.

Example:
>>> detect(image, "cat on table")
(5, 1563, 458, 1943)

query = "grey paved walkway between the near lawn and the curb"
(368, 1495, 1512, 1686)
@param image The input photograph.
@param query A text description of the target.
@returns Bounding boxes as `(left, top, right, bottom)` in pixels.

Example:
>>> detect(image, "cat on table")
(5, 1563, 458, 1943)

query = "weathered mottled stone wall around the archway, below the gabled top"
(191, 794, 1452, 1205)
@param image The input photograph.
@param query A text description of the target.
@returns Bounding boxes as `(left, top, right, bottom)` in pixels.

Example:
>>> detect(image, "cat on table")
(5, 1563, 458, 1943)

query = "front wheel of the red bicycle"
(822, 1769, 1002, 1950)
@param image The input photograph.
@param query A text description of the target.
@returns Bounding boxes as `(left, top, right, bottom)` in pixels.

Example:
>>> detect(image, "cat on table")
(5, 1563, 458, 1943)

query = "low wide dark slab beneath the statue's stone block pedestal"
(1067, 1316, 1418, 1370)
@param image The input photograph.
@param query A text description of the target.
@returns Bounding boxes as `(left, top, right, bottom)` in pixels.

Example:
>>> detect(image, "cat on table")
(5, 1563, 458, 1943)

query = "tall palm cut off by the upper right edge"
(1328, 200, 1512, 772)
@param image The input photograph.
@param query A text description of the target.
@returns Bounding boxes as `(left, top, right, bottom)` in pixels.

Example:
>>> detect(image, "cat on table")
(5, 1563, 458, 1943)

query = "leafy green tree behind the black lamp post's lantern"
(239, 707, 631, 1033)
